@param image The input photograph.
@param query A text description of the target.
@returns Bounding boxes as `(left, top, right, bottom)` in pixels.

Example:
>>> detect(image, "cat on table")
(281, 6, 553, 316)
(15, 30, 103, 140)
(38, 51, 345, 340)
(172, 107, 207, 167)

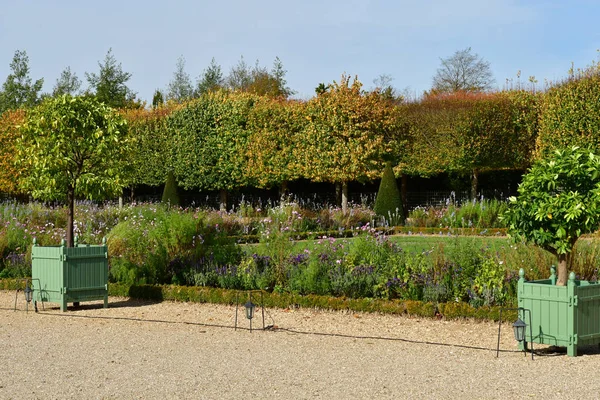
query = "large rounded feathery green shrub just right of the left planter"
(107, 208, 240, 284)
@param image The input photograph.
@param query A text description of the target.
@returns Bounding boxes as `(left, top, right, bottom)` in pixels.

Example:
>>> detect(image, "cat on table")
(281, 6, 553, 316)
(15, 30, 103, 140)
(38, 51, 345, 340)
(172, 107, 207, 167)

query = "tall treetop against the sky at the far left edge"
(0, 50, 44, 114)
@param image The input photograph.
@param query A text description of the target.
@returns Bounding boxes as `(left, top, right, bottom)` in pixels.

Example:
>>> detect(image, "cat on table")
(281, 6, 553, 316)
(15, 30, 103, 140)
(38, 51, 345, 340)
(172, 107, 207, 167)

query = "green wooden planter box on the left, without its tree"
(31, 239, 108, 311)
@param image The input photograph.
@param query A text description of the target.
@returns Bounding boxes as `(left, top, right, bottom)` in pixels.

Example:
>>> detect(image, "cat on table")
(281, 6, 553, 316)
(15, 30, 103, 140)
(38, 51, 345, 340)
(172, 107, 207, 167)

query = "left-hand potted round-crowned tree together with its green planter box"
(17, 95, 130, 311)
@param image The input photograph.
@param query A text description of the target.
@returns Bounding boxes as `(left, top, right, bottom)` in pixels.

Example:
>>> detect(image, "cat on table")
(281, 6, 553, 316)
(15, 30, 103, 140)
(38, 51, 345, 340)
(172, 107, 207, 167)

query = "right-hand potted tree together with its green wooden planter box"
(505, 147, 600, 356)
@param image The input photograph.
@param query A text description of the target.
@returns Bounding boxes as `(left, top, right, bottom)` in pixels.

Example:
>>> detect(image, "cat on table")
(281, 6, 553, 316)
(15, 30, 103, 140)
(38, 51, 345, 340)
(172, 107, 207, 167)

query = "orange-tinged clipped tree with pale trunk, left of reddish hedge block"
(295, 75, 396, 212)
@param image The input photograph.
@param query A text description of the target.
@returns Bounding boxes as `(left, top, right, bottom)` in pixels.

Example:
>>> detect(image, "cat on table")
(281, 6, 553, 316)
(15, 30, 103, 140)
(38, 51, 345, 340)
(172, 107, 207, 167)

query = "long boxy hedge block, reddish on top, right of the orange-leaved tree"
(397, 91, 539, 176)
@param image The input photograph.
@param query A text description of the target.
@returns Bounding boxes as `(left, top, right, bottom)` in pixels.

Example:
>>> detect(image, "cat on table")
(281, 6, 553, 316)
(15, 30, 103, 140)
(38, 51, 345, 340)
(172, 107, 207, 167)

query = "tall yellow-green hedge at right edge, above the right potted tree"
(537, 64, 600, 156)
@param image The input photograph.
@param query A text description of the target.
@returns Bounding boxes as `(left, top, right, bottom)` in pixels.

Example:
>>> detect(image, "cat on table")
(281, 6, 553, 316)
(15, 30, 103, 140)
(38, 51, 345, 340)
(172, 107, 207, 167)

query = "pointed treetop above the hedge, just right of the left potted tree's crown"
(85, 48, 139, 108)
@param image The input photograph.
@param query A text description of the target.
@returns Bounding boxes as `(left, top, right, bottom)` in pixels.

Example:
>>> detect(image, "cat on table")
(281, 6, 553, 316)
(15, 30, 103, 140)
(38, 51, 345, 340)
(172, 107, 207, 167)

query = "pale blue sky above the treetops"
(0, 0, 600, 101)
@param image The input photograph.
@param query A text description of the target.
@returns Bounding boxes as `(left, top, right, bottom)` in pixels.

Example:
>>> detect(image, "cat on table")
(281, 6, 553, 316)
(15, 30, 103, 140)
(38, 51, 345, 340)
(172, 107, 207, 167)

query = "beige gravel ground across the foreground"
(0, 291, 600, 400)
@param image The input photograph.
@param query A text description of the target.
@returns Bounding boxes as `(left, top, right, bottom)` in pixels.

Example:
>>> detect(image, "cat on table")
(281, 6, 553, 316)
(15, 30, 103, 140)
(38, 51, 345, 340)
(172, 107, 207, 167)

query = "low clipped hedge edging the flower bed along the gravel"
(0, 279, 517, 321)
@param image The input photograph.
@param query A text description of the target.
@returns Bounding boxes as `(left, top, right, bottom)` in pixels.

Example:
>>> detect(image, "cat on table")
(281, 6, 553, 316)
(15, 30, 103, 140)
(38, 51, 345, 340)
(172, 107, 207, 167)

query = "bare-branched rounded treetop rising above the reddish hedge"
(432, 47, 495, 93)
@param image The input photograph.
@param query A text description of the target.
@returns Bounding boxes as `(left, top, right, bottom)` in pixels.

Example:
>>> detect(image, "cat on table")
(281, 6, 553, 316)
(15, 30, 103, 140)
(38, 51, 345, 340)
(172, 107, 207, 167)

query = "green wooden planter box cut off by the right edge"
(517, 267, 600, 357)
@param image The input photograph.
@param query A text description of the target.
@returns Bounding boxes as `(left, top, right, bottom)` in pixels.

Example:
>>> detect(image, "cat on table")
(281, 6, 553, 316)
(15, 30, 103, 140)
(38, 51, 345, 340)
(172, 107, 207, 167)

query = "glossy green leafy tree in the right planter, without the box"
(505, 147, 600, 286)
